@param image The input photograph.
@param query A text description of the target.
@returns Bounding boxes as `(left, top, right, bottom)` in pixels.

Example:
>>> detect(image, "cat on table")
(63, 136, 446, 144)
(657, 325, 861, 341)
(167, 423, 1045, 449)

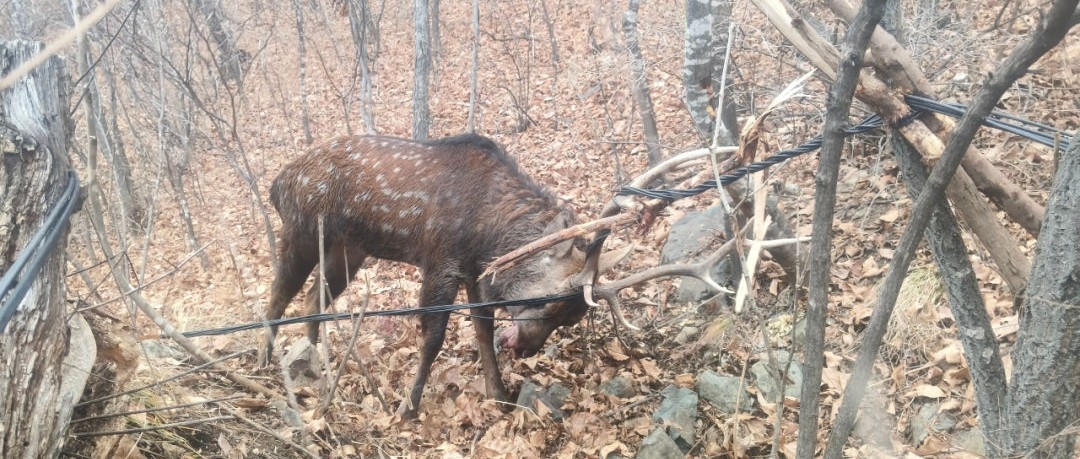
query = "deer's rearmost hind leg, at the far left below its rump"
(259, 230, 319, 365)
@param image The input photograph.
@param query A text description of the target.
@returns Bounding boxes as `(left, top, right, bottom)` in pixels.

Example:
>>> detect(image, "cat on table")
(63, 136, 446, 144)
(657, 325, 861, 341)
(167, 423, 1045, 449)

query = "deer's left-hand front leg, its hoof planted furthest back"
(399, 272, 461, 419)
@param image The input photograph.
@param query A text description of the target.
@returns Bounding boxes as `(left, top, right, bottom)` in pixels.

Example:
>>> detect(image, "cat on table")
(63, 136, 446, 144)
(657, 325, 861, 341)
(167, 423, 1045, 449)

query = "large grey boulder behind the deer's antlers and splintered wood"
(660, 205, 727, 302)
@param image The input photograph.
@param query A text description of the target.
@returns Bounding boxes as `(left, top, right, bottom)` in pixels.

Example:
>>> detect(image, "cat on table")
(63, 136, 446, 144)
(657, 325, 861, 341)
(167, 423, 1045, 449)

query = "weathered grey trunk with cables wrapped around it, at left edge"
(0, 41, 96, 458)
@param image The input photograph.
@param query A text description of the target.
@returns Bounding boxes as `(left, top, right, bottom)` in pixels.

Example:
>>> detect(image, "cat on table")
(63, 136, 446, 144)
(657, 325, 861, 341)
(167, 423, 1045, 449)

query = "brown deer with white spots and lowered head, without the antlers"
(266, 134, 622, 418)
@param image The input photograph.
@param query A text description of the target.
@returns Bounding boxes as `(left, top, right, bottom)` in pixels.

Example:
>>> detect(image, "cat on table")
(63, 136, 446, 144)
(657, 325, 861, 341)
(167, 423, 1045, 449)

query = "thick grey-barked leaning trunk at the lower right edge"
(999, 132, 1080, 458)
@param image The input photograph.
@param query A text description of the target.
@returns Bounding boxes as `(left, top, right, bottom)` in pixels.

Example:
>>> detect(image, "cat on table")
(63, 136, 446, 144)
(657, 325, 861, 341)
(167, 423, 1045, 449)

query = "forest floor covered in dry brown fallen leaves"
(61, 1, 1080, 458)
